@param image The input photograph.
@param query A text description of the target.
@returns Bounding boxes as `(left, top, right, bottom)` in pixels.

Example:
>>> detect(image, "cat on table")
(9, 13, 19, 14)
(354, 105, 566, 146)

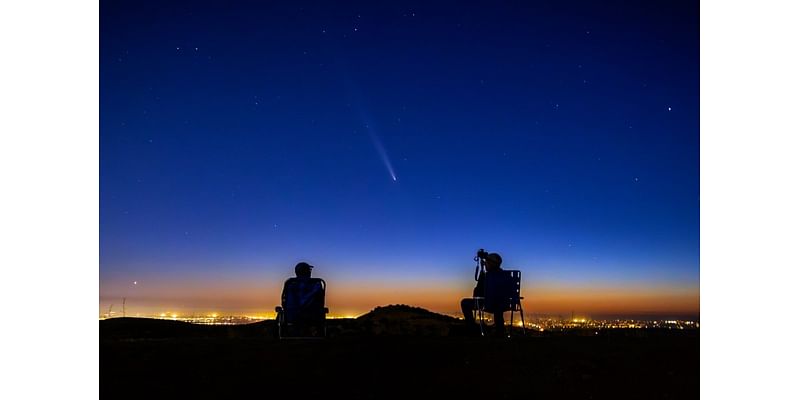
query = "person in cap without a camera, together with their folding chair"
(275, 262, 328, 336)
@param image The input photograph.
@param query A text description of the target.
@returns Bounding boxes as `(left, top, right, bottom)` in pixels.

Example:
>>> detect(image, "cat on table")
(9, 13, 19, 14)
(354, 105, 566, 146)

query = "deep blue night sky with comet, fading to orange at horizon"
(99, 1, 700, 315)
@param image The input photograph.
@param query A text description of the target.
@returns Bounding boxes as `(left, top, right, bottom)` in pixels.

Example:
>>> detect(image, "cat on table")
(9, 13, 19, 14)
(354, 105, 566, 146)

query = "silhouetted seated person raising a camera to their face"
(461, 253, 507, 336)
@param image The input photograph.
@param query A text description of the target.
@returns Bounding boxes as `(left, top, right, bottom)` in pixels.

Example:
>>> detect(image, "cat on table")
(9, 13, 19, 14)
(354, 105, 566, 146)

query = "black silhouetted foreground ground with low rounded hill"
(100, 308, 700, 399)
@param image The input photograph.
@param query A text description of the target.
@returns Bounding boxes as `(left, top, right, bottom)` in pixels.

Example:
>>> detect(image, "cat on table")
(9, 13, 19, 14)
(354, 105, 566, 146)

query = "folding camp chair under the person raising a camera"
(474, 270, 525, 337)
